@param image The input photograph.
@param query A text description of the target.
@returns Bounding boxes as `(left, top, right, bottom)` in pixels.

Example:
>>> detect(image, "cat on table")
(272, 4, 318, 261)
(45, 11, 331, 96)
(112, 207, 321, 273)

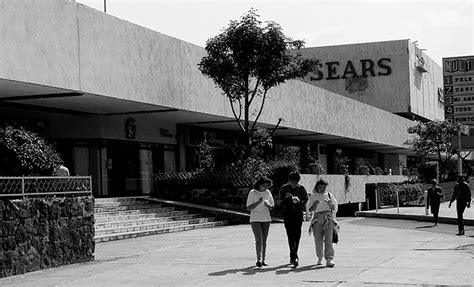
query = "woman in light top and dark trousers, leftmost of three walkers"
(247, 177, 275, 267)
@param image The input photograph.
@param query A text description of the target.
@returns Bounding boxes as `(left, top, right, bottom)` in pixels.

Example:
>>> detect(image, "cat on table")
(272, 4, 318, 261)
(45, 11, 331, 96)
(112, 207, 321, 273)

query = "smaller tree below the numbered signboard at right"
(405, 121, 463, 181)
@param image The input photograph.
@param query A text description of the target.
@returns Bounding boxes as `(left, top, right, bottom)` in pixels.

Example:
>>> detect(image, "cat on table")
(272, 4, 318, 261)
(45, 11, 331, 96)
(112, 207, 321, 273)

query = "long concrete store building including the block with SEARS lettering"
(0, 0, 443, 196)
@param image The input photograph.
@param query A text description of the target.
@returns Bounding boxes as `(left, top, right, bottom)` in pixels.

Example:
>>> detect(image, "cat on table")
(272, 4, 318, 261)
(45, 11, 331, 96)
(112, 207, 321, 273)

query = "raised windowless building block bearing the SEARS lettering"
(302, 40, 444, 121)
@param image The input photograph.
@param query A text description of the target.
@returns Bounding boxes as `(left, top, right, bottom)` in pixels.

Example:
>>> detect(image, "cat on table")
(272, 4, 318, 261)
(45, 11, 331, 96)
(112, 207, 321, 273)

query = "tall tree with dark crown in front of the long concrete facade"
(198, 9, 319, 158)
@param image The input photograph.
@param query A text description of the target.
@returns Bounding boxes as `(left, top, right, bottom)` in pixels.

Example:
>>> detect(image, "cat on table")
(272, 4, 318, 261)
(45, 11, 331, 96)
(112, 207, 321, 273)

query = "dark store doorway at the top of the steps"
(107, 143, 141, 197)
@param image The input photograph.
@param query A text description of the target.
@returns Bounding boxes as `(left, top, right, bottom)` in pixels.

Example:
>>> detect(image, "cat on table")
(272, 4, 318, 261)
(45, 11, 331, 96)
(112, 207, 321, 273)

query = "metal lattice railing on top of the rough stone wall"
(0, 176, 92, 197)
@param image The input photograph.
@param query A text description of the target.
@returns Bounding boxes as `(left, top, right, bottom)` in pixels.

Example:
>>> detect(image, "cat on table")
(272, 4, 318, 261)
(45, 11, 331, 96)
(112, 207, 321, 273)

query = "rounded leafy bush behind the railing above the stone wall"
(0, 127, 63, 176)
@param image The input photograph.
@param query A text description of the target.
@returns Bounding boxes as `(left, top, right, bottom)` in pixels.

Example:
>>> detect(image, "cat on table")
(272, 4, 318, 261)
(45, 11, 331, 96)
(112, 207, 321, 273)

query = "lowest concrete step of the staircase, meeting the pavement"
(94, 221, 227, 243)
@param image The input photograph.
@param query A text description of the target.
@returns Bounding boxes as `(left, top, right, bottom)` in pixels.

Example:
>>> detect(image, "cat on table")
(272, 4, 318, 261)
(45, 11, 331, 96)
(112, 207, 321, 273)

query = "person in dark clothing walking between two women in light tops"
(279, 171, 308, 267)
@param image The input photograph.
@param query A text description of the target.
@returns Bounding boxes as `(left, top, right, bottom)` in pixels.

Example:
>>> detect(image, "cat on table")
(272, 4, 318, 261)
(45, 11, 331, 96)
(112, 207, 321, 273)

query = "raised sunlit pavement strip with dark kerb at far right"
(356, 202, 474, 226)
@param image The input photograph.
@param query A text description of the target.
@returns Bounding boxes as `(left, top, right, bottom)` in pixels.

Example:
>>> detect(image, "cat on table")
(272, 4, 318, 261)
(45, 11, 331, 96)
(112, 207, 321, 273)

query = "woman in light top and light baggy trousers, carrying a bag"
(306, 179, 337, 267)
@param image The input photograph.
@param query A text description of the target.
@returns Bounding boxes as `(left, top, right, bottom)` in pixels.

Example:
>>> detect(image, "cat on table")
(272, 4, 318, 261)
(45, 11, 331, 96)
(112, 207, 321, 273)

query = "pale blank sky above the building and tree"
(76, 0, 474, 65)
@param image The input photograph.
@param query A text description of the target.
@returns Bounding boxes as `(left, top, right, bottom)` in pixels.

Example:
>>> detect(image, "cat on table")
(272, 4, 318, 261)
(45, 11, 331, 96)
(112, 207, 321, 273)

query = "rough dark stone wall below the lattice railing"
(0, 196, 95, 278)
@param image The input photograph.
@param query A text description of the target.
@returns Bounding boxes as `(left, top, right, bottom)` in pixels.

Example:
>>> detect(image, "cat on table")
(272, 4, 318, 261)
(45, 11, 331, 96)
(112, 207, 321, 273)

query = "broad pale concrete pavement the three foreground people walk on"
(0, 218, 474, 287)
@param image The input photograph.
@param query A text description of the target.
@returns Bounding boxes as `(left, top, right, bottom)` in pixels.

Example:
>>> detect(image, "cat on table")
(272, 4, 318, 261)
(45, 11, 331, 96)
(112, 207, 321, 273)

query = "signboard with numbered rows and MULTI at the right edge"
(443, 56, 474, 126)
